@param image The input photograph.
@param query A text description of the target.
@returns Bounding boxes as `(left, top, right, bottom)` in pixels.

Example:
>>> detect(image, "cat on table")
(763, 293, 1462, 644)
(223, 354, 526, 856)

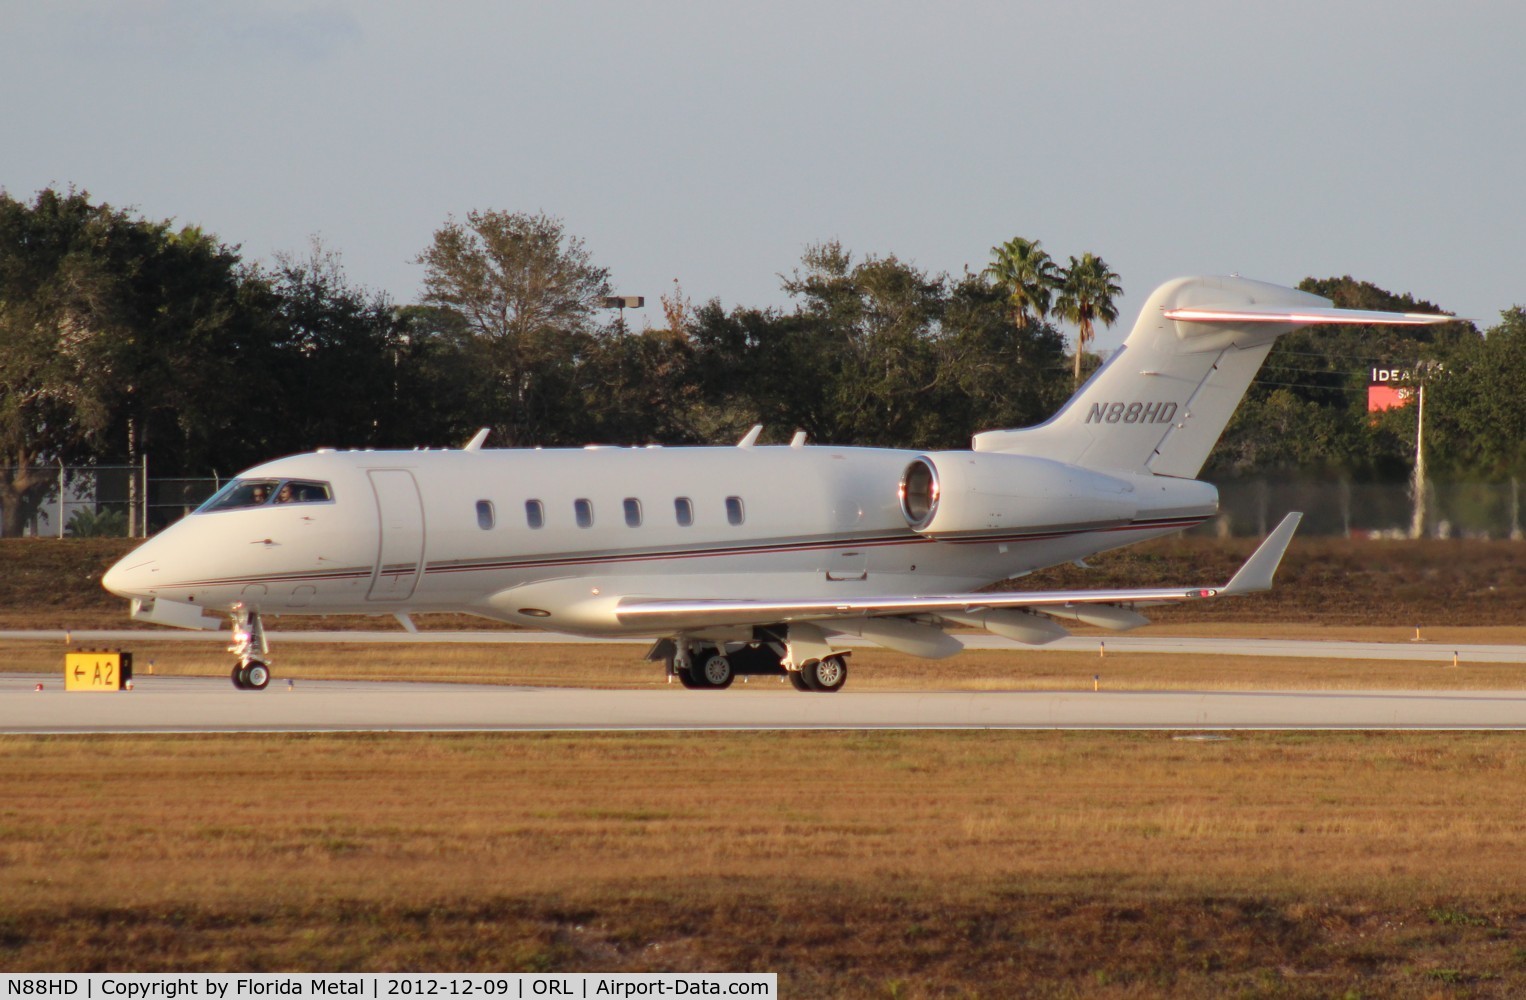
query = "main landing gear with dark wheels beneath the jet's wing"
(647, 629, 848, 695)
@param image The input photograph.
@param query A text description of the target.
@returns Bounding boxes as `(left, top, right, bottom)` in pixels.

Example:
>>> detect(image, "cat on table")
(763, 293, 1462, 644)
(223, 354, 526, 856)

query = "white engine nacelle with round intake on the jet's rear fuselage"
(900, 452, 1138, 536)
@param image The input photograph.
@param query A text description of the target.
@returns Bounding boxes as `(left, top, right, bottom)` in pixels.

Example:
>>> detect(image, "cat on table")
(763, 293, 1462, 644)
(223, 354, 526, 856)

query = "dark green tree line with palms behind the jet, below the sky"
(0, 189, 1526, 534)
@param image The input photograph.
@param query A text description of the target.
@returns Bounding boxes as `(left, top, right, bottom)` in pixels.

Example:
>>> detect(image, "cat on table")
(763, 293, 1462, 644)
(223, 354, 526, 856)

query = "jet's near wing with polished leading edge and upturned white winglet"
(615, 513, 1303, 629)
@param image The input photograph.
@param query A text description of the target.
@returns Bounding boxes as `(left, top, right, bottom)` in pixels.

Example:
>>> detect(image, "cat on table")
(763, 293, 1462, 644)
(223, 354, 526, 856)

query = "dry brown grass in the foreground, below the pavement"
(0, 733, 1526, 997)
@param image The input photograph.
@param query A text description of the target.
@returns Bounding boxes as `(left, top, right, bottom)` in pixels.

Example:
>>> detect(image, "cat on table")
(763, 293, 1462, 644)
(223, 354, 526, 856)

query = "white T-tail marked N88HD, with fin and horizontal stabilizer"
(974, 278, 1454, 479)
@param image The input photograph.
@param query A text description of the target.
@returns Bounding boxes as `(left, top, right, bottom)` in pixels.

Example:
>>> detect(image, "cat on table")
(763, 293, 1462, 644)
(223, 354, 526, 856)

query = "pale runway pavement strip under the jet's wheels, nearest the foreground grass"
(0, 673, 1526, 734)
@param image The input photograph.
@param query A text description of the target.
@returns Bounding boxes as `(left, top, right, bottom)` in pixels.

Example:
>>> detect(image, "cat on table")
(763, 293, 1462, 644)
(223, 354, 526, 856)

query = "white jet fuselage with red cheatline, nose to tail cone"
(105, 446, 1218, 634)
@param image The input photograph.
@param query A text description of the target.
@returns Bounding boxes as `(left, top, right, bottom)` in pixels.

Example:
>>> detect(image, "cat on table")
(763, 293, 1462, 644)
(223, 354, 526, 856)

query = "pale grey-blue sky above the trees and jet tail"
(0, 0, 1526, 347)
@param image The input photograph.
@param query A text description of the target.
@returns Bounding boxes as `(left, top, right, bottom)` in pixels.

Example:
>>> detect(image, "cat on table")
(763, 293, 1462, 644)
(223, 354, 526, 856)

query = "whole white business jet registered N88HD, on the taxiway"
(104, 278, 1453, 692)
